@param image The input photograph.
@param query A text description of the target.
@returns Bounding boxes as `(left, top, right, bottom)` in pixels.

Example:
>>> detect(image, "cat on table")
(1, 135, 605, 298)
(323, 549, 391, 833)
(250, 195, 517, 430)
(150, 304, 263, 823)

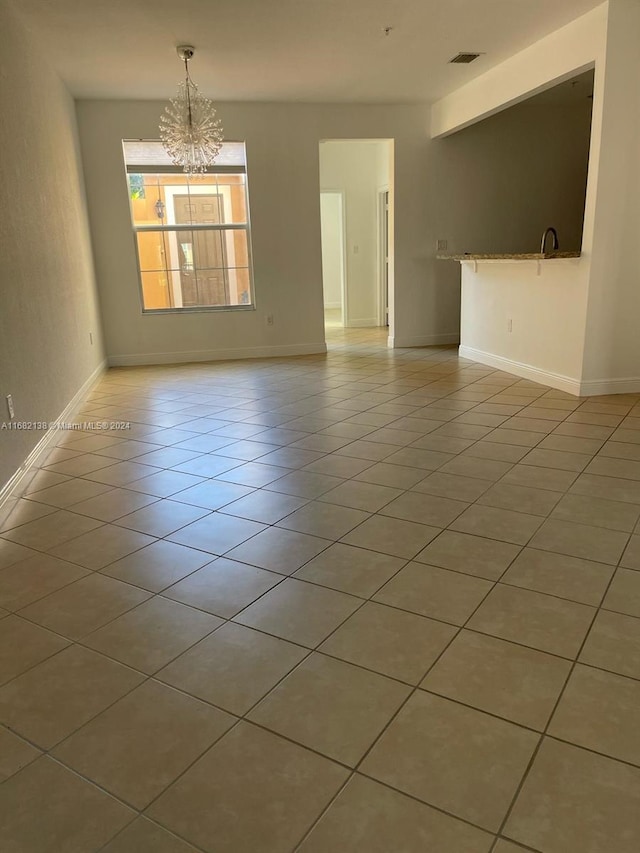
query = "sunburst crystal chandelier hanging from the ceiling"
(160, 45, 223, 175)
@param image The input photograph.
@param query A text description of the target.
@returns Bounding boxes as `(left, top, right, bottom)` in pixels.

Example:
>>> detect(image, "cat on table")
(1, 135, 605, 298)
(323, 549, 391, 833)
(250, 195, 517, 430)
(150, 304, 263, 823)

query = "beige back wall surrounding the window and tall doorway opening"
(77, 101, 458, 363)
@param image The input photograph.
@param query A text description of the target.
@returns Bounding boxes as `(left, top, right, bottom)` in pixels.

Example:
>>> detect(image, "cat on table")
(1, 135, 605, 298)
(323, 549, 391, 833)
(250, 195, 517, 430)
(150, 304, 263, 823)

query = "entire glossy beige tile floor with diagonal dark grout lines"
(0, 328, 640, 853)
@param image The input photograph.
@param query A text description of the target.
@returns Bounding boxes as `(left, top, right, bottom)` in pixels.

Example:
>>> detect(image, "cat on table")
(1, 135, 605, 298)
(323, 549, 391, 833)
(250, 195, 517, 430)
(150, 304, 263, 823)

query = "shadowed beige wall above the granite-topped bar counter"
(429, 98, 591, 254)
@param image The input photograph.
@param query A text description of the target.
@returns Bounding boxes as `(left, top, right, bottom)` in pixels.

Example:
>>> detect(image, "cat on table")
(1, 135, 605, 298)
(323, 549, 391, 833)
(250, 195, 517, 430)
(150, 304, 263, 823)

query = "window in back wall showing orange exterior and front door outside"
(123, 140, 253, 311)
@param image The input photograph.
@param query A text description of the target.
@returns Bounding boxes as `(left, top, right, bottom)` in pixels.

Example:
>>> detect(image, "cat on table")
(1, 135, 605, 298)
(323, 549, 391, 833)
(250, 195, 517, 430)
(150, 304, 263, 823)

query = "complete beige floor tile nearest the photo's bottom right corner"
(361, 691, 539, 831)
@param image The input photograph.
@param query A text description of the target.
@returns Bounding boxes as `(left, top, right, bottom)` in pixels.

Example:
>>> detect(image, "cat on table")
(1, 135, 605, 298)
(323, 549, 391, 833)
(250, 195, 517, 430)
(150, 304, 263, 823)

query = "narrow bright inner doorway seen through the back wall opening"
(320, 190, 347, 328)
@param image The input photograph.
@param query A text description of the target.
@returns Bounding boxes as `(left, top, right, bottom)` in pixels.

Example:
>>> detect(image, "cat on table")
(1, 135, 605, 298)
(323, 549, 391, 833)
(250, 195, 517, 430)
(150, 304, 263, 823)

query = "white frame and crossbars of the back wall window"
(123, 145, 256, 315)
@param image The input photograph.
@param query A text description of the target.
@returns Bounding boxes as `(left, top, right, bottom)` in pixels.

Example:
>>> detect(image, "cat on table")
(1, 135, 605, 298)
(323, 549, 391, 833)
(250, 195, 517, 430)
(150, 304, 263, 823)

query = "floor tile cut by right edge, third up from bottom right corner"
(580, 610, 640, 679)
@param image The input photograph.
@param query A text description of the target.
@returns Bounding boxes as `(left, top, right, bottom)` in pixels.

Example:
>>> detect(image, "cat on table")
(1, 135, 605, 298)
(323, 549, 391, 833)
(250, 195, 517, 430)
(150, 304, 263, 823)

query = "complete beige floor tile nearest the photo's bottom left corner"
(53, 681, 235, 809)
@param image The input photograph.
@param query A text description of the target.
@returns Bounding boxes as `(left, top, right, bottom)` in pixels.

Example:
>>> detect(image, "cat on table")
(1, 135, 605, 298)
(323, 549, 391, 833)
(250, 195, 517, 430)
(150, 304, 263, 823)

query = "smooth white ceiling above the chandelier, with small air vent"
(11, 0, 601, 103)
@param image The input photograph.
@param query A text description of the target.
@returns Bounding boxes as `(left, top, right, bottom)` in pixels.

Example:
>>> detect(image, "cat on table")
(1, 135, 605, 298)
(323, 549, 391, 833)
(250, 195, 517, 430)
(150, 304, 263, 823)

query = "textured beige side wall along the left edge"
(0, 3, 103, 489)
